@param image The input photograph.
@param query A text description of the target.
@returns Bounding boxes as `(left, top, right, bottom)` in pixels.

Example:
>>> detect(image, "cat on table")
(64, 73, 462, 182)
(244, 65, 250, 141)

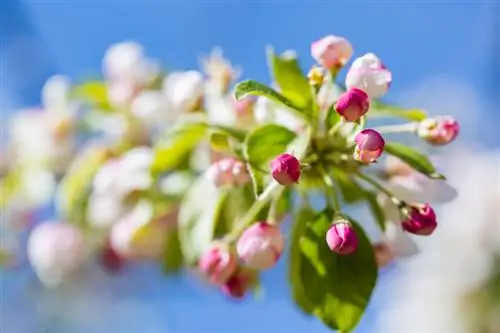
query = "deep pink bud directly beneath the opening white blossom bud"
(335, 88, 370, 121)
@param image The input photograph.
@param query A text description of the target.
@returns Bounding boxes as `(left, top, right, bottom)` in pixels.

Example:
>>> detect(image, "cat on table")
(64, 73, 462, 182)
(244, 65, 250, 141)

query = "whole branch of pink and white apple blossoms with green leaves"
(2, 35, 459, 332)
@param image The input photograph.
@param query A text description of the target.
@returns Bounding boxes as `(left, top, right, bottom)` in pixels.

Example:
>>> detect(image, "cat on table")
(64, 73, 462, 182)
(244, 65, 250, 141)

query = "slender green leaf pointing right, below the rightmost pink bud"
(384, 142, 446, 180)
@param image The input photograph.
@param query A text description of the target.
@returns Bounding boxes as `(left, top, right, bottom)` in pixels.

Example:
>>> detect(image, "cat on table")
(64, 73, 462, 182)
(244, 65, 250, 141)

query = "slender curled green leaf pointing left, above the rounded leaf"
(234, 80, 307, 115)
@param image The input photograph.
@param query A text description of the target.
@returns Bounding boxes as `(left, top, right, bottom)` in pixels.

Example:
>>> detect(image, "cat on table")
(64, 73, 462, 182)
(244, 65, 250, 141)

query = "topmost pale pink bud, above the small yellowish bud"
(311, 35, 353, 69)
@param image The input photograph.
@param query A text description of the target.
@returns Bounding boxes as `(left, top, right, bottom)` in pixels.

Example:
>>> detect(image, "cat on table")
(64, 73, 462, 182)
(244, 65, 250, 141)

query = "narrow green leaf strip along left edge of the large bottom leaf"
(288, 207, 317, 314)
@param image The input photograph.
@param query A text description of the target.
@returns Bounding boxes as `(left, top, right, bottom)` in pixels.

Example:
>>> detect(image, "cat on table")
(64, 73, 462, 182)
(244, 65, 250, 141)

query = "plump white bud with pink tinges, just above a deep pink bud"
(345, 53, 392, 98)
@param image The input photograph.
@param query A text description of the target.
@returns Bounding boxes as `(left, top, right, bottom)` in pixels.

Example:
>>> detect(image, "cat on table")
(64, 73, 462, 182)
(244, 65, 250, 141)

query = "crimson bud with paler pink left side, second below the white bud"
(354, 129, 385, 164)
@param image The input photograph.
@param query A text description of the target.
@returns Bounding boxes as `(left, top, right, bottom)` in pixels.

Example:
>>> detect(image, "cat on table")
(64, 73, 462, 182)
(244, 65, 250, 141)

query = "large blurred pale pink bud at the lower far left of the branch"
(27, 222, 86, 287)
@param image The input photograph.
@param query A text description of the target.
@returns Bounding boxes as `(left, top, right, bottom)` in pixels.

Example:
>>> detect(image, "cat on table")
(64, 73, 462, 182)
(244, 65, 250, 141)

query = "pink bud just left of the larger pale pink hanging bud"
(198, 246, 237, 285)
